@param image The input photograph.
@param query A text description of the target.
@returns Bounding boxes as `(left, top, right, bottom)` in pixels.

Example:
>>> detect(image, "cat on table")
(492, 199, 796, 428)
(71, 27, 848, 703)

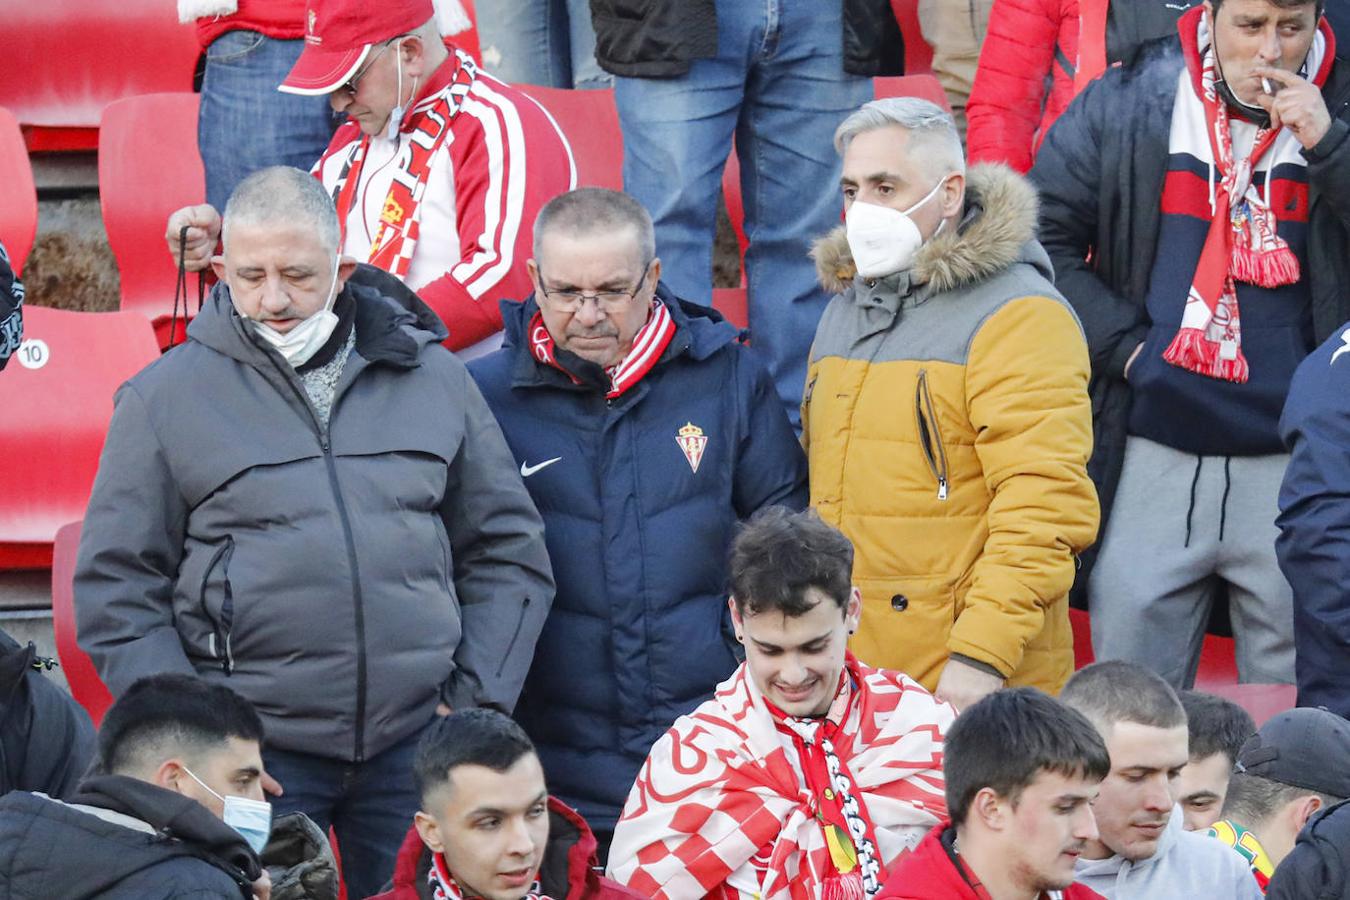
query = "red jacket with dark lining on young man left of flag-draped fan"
(371, 796, 640, 900)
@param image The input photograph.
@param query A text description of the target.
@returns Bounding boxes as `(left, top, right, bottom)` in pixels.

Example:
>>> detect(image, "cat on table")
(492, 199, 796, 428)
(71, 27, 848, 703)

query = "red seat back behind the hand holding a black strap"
(99, 93, 207, 347)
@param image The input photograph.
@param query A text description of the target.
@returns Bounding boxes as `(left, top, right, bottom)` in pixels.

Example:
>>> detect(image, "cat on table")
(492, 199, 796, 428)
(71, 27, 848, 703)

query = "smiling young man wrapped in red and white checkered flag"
(609, 509, 954, 900)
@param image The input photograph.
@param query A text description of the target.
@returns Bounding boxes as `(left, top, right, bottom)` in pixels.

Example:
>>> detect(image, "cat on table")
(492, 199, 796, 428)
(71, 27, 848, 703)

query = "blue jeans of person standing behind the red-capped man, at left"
(197, 31, 343, 209)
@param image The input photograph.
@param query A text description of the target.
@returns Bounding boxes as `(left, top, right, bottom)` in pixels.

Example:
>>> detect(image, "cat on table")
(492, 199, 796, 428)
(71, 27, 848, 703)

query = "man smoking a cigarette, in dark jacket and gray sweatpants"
(1031, 0, 1350, 687)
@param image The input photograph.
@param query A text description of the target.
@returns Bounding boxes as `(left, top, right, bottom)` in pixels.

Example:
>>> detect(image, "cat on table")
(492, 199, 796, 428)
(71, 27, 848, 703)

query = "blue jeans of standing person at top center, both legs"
(614, 0, 872, 424)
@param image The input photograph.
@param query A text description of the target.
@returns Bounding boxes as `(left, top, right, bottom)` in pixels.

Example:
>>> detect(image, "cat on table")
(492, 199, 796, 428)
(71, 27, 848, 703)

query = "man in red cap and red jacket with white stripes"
(166, 0, 576, 355)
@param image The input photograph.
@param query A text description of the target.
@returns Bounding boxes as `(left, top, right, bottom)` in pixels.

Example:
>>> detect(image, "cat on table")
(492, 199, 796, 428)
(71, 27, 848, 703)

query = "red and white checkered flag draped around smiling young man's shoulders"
(609, 654, 953, 900)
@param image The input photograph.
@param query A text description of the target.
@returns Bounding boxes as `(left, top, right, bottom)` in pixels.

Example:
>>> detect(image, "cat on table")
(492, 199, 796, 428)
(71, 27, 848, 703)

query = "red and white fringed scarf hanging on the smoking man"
(1162, 7, 1330, 383)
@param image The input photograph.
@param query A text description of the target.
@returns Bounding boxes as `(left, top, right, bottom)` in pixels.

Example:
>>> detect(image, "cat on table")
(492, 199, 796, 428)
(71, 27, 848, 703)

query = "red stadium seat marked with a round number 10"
(0, 306, 159, 569)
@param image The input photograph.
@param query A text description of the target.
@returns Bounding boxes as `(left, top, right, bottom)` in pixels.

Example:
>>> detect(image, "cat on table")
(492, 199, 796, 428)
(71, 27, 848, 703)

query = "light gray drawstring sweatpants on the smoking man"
(1088, 436, 1293, 688)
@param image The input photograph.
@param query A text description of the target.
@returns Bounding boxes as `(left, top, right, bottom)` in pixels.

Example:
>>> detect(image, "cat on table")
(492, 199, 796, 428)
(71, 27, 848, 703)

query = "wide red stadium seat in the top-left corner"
(0, 0, 200, 151)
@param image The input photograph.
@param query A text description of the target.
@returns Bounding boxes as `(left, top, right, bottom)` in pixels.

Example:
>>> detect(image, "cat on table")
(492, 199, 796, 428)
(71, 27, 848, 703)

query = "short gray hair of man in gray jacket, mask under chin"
(220, 166, 342, 254)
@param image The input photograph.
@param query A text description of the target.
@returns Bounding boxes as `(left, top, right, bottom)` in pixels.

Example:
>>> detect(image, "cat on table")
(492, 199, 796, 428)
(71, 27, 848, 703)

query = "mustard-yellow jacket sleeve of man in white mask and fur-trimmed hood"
(948, 297, 1099, 676)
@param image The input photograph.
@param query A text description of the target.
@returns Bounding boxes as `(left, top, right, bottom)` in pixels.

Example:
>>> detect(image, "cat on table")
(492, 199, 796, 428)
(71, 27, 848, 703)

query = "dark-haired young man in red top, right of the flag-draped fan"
(878, 688, 1111, 900)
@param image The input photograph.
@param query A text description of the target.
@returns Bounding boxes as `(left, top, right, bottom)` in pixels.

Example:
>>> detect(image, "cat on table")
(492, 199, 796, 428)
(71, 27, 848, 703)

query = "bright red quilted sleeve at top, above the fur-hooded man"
(965, 0, 1061, 173)
